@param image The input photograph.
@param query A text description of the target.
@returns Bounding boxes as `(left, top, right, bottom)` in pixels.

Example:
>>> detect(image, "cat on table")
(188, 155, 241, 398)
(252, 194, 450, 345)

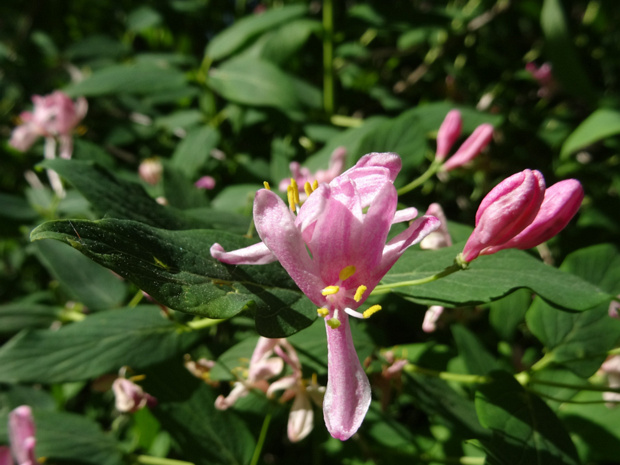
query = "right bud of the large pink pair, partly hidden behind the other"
(488, 179, 583, 253)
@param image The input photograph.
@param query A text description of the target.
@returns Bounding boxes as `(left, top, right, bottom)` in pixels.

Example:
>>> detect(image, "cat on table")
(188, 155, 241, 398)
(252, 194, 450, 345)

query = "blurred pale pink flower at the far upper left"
(9, 91, 88, 158)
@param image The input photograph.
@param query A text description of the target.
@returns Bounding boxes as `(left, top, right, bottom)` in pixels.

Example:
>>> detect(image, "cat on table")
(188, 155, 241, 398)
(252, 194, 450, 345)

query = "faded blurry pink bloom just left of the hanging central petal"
(215, 337, 284, 410)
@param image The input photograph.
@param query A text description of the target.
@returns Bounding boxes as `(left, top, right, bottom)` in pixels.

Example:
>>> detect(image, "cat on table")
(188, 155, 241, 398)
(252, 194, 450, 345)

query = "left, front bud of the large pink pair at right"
(463, 170, 545, 262)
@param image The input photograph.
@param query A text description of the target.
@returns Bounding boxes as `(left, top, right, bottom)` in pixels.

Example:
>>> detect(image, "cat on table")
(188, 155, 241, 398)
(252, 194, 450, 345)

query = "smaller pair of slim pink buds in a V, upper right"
(435, 110, 493, 171)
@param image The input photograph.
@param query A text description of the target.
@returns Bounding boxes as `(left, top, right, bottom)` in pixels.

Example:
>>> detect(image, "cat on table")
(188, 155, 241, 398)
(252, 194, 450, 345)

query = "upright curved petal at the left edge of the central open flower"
(254, 189, 325, 307)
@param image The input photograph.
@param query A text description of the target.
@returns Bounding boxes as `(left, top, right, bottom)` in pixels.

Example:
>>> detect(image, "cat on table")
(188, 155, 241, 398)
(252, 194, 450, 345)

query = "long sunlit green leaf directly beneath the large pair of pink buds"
(382, 243, 610, 310)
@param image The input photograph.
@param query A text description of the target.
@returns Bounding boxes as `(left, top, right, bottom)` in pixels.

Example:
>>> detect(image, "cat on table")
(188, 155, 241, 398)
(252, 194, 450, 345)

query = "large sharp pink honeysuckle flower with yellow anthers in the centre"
(211, 153, 439, 440)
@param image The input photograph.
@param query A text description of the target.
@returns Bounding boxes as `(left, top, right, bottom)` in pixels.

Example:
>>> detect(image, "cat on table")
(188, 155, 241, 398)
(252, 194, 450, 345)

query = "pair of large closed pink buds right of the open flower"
(463, 170, 584, 262)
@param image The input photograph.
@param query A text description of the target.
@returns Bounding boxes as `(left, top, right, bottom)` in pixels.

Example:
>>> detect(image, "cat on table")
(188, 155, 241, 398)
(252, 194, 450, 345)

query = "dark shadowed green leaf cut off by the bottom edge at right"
(476, 373, 579, 465)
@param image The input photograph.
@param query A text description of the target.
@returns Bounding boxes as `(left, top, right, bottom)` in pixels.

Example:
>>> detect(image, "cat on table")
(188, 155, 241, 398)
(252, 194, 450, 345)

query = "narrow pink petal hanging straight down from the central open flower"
(323, 312, 371, 441)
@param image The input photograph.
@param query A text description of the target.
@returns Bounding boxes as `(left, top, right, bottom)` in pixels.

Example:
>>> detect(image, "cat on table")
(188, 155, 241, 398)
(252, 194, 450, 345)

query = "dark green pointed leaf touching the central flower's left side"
(30, 219, 317, 337)
